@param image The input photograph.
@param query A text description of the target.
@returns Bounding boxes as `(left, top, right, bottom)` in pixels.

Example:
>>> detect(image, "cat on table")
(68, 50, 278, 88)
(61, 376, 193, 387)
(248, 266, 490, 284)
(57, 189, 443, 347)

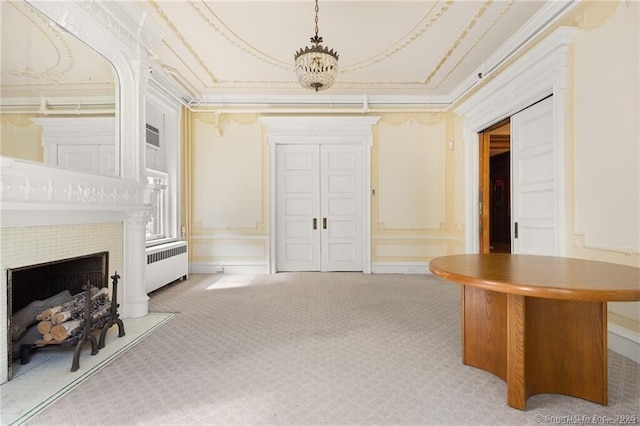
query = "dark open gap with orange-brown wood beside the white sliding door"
(478, 118, 511, 253)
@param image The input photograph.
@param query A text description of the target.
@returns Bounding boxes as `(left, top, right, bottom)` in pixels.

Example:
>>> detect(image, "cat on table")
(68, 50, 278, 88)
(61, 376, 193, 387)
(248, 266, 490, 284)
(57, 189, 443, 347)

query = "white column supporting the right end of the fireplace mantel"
(122, 210, 150, 318)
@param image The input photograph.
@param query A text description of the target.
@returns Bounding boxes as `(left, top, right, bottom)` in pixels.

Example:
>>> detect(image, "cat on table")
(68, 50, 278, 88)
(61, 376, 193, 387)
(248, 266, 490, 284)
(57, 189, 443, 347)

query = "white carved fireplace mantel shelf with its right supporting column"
(0, 157, 155, 330)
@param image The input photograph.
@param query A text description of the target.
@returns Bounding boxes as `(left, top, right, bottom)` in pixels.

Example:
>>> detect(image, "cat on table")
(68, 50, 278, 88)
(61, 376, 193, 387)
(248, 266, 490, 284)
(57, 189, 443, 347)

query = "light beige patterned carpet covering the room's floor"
(22, 273, 640, 425)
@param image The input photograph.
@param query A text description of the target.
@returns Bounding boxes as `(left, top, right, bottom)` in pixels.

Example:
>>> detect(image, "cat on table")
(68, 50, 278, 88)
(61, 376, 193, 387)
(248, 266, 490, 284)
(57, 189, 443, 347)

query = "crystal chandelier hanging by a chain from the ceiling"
(293, 0, 338, 92)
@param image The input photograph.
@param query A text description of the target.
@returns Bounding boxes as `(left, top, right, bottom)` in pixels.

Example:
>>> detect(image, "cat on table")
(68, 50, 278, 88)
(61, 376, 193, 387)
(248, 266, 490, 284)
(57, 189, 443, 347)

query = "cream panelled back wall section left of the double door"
(188, 113, 269, 273)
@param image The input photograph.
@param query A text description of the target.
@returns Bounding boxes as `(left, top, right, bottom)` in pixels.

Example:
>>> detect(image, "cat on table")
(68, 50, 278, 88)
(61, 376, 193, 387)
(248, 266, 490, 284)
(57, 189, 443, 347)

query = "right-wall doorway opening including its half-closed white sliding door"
(479, 96, 562, 255)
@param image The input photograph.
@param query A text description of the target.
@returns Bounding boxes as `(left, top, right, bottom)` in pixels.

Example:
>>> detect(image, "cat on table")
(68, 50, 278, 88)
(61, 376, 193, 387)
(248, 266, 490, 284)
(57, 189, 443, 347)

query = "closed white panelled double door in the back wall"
(276, 144, 363, 271)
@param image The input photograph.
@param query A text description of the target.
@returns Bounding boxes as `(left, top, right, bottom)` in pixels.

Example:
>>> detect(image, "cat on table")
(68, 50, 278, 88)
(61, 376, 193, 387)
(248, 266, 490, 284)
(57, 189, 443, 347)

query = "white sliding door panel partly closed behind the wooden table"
(511, 98, 558, 255)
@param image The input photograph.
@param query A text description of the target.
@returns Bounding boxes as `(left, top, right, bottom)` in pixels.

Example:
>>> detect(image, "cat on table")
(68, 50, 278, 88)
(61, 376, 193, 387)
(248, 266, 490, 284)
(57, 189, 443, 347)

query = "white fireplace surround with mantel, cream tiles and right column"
(0, 157, 153, 383)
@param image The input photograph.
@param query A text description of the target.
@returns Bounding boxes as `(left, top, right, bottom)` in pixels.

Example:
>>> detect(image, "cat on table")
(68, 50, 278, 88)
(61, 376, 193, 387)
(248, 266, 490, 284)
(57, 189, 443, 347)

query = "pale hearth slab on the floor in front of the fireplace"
(0, 313, 173, 425)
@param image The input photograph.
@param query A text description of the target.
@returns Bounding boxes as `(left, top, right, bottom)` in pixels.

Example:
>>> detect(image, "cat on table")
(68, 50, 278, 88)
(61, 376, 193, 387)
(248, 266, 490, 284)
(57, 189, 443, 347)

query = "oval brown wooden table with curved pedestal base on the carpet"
(429, 253, 640, 410)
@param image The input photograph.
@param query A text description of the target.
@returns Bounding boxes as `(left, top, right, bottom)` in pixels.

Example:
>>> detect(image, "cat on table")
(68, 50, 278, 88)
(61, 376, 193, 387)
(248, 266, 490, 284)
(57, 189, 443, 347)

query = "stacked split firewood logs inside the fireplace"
(36, 287, 111, 345)
